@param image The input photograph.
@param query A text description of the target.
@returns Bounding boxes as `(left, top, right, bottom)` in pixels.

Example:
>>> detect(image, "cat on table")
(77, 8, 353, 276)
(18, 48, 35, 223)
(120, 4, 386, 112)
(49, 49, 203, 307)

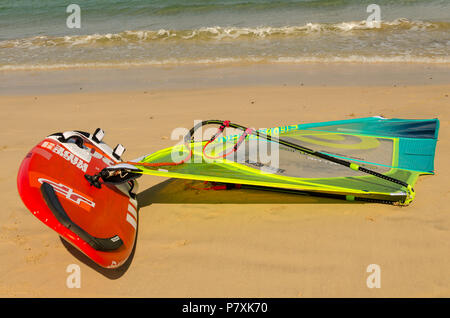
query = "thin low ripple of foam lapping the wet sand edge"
(0, 55, 450, 71)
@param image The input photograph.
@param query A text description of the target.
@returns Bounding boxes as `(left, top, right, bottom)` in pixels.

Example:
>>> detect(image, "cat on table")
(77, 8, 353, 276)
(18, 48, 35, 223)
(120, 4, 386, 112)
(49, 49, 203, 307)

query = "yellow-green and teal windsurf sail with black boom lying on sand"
(96, 117, 439, 205)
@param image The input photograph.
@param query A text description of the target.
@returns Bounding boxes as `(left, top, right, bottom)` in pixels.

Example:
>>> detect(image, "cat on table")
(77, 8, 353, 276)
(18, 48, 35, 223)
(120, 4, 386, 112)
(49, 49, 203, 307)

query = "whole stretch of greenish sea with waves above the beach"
(0, 0, 450, 71)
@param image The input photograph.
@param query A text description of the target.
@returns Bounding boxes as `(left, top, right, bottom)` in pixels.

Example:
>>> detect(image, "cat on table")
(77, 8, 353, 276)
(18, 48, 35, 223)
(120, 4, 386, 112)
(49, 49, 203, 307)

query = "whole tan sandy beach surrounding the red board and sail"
(0, 65, 450, 297)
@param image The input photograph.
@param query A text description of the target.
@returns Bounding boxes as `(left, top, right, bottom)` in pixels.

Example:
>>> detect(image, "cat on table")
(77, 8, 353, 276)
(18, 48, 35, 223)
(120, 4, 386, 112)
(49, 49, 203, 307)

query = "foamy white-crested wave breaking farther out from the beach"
(0, 19, 450, 49)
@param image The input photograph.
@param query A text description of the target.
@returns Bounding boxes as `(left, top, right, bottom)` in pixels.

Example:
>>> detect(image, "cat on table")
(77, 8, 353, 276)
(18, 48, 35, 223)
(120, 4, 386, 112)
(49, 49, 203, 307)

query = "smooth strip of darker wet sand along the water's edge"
(0, 63, 450, 96)
